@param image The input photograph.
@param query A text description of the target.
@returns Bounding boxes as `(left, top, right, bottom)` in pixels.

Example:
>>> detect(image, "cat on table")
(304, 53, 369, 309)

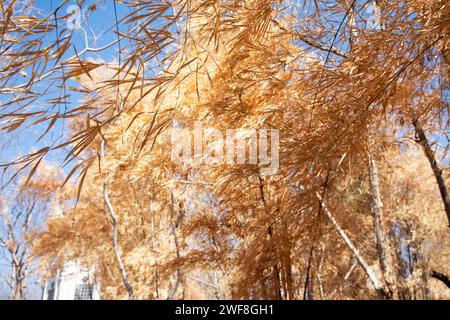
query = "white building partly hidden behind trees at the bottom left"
(42, 262, 100, 300)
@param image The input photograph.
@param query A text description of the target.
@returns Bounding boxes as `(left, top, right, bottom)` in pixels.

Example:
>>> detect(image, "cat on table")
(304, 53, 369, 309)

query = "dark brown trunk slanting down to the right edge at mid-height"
(412, 118, 450, 227)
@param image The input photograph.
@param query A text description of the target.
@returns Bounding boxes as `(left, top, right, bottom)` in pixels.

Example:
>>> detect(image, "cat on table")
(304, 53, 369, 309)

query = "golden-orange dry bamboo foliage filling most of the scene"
(0, 0, 450, 299)
